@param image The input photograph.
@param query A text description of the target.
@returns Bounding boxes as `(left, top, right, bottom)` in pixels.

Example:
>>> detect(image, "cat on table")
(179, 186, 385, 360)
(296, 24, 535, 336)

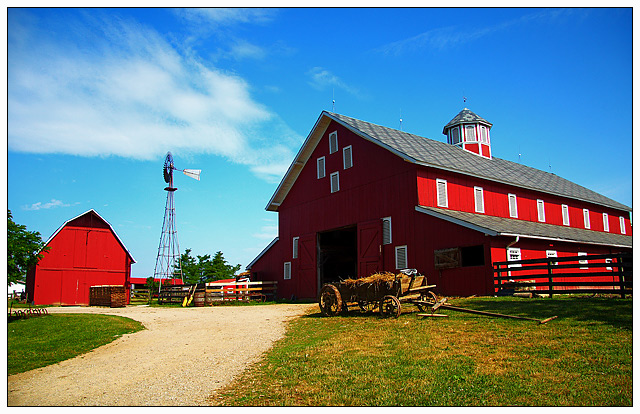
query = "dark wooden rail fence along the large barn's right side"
(493, 253, 633, 298)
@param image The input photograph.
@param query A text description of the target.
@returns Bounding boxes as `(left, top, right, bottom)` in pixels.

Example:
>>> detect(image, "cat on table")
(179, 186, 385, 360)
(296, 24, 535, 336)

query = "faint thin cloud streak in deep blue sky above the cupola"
(374, 9, 574, 56)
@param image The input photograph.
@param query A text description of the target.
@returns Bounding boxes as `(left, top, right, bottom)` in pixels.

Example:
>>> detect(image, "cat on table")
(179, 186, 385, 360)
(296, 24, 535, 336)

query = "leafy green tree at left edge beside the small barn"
(7, 210, 49, 285)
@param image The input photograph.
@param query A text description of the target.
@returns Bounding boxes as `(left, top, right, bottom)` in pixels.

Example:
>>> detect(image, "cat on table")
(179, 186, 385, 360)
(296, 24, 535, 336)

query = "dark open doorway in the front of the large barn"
(318, 226, 358, 286)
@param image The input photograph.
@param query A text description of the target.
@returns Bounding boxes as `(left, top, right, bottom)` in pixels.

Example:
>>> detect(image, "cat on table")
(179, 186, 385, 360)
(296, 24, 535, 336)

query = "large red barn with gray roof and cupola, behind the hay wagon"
(248, 108, 632, 298)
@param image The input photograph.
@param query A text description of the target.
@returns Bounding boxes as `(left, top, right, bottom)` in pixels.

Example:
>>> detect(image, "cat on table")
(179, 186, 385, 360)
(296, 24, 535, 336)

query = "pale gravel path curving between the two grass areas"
(7, 304, 315, 406)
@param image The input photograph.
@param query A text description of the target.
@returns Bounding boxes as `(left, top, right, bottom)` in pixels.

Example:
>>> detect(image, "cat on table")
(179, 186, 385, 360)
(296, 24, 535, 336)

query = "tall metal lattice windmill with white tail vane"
(153, 152, 201, 287)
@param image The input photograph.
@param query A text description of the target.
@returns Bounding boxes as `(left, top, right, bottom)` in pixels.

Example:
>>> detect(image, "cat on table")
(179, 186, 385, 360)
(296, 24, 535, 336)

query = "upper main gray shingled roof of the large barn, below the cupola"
(324, 112, 631, 211)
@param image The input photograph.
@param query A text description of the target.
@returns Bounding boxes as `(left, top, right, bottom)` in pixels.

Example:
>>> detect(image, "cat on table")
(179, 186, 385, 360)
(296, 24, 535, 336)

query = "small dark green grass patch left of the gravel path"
(7, 314, 144, 375)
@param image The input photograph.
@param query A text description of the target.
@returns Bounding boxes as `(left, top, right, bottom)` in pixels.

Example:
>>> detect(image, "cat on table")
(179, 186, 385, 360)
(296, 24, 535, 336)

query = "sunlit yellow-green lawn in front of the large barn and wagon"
(210, 298, 632, 406)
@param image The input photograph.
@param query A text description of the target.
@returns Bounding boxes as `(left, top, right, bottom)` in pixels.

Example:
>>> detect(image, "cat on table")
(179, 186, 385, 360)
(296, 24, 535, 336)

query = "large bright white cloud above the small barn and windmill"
(8, 9, 301, 181)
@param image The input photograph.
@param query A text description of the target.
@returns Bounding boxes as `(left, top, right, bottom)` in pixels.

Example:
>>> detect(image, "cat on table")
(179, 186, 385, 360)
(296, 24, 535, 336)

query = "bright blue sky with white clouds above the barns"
(7, 8, 632, 277)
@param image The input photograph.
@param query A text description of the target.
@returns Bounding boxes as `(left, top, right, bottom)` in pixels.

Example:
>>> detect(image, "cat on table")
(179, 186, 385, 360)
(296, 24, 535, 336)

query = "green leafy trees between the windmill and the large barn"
(180, 249, 240, 284)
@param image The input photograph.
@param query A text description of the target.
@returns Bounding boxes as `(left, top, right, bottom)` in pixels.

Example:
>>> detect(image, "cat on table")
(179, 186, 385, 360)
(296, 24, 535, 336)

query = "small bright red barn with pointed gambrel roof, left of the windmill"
(27, 210, 135, 306)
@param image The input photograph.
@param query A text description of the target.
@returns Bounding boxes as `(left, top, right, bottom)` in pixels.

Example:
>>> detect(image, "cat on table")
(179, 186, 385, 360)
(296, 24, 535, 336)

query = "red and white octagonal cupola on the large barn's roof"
(442, 108, 493, 159)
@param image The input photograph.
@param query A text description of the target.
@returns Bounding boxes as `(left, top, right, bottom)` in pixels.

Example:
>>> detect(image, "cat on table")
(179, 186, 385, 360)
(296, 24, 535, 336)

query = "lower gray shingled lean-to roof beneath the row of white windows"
(416, 206, 633, 247)
